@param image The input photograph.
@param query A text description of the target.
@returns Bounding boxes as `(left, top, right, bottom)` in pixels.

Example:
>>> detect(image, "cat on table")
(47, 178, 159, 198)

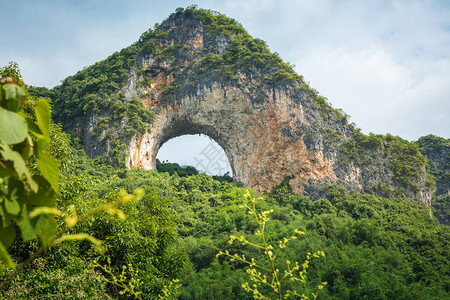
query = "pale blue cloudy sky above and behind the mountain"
(0, 0, 450, 175)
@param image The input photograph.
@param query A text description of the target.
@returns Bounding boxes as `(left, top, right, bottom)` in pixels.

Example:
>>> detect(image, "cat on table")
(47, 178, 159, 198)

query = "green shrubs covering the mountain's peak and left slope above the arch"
(47, 6, 334, 168)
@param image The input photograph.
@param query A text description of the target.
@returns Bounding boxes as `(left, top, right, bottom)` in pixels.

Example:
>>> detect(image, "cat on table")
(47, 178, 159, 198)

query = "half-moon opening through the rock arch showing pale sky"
(156, 134, 233, 177)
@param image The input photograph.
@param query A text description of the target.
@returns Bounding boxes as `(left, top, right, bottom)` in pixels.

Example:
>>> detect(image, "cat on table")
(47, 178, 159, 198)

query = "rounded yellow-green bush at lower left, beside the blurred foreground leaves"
(60, 188, 187, 298)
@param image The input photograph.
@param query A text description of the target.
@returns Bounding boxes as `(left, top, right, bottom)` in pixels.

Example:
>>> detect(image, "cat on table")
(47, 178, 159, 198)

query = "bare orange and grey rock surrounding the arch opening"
(127, 83, 335, 190)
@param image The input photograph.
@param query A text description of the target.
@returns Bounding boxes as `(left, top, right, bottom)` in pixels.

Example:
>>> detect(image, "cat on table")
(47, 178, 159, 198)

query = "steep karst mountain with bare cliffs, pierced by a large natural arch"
(52, 7, 434, 205)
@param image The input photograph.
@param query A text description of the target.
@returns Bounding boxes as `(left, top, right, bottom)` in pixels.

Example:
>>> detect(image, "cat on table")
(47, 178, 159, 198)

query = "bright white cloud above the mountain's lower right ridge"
(295, 42, 450, 140)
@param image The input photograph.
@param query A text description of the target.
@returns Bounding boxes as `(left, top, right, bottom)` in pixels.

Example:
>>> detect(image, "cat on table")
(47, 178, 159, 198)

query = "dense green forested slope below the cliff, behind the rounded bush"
(81, 164, 442, 299)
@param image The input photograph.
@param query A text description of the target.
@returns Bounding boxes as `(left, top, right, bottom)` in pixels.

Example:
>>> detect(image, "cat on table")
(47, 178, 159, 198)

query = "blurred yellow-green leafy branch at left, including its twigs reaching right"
(0, 69, 143, 288)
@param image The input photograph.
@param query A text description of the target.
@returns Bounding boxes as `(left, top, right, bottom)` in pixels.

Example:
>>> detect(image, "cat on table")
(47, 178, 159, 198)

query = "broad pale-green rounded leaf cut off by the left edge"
(0, 107, 28, 145)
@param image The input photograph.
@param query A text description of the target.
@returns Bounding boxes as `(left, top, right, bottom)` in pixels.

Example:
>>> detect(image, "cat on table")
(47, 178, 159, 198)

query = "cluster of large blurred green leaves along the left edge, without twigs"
(0, 69, 59, 275)
